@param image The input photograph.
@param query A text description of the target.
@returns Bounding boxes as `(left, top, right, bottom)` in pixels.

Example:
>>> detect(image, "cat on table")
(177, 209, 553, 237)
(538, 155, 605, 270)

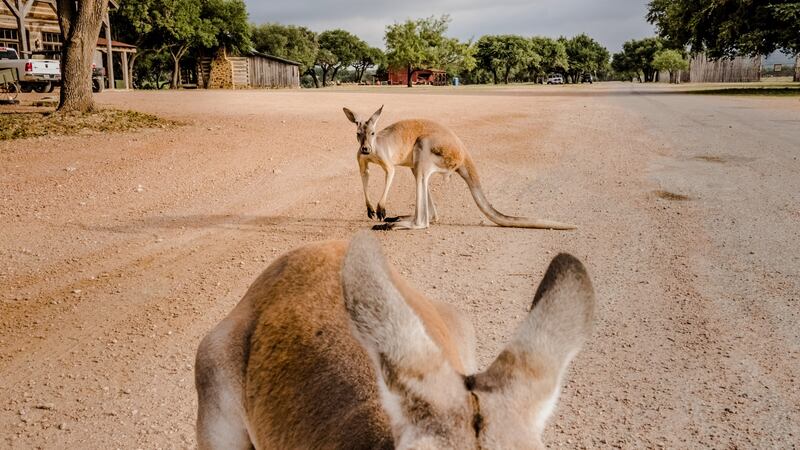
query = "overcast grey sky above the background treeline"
(245, 0, 654, 52)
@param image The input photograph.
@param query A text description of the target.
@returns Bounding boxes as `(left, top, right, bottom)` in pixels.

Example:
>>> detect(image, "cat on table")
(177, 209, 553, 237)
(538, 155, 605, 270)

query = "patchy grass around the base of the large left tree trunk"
(0, 109, 180, 141)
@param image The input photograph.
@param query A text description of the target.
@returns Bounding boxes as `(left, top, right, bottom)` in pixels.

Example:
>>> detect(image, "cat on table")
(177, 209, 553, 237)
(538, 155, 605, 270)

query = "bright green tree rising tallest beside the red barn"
(384, 15, 466, 87)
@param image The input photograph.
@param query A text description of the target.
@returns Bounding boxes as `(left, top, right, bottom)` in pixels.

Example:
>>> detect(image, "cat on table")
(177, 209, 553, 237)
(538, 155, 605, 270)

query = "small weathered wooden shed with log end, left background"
(197, 50, 300, 89)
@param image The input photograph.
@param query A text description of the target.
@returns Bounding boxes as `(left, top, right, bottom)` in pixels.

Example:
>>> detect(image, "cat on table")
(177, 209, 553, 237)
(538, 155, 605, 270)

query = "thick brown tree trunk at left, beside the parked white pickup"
(57, 0, 109, 112)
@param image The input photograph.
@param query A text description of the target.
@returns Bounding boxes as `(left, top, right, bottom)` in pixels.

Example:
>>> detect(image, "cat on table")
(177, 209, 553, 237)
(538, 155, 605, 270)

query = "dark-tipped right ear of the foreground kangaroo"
(468, 254, 595, 431)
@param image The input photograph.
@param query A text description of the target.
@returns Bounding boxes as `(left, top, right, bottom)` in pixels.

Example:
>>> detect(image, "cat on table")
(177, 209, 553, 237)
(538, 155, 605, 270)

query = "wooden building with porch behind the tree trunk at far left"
(0, 0, 136, 89)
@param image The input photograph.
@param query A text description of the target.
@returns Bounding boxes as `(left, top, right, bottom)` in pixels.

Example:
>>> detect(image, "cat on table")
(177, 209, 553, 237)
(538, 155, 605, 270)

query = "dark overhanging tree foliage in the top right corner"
(647, 0, 800, 81)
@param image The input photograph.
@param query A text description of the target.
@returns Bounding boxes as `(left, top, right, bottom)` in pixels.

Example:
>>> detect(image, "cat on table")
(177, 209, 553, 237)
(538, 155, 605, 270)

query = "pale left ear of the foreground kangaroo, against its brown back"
(342, 231, 442, 369)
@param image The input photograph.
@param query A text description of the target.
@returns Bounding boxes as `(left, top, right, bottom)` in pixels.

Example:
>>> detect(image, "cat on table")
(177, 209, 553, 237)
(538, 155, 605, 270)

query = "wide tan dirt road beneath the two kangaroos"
(0, 84, 800, 449)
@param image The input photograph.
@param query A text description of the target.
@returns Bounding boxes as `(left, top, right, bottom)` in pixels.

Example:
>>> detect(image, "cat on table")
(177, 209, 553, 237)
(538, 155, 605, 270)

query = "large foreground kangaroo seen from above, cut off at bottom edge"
(195, 232, 595, 450)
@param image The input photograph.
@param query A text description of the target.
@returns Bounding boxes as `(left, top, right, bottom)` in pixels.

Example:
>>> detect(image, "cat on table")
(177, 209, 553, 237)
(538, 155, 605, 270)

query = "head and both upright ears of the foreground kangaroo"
(342, 233, 595, 450)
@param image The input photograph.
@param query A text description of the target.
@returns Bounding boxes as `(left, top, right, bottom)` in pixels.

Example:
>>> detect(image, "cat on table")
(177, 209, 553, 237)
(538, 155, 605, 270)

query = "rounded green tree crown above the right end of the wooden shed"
(250, 23, 319, 73)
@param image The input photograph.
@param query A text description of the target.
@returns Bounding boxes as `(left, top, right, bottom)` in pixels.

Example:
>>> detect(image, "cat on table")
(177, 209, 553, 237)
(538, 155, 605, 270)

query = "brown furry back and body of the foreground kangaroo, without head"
(196, 237, 474, 449)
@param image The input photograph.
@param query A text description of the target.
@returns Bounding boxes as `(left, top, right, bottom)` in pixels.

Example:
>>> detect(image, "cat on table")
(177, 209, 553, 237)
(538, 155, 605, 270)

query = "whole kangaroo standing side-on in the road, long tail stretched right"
(343, 106, 576, 230)
